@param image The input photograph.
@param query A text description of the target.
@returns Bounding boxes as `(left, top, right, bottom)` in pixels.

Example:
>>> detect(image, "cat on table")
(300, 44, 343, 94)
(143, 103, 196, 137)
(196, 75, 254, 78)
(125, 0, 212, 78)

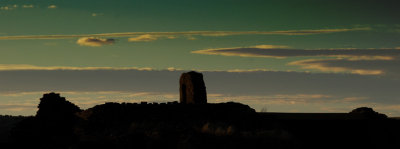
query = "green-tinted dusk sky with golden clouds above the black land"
(0, 0, 400, 117)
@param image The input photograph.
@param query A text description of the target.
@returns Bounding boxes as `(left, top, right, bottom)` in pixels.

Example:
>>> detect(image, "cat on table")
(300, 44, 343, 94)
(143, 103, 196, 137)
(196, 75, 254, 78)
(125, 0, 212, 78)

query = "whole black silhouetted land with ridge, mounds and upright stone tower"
(3, 71, 400, 149)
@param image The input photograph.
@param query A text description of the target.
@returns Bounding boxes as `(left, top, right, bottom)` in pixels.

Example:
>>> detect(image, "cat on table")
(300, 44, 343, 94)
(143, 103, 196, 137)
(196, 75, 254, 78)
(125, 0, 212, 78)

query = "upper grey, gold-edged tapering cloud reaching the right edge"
(192, 45, 400, 61)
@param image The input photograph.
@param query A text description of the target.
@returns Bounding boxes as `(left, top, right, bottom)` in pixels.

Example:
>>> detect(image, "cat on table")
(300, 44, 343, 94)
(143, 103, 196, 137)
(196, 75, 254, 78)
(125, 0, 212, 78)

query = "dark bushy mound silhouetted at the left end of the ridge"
(10, 92, 82, 149)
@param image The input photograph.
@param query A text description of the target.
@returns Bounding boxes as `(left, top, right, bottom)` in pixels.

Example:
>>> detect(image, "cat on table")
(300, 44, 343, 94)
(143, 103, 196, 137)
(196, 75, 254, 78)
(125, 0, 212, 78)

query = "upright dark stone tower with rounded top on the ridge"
(179, 71, 207, 104)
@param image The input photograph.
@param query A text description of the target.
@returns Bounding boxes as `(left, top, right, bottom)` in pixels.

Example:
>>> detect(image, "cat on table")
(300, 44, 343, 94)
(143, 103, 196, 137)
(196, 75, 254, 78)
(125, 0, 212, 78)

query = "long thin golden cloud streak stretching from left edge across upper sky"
(0, 28, 370, 40)
